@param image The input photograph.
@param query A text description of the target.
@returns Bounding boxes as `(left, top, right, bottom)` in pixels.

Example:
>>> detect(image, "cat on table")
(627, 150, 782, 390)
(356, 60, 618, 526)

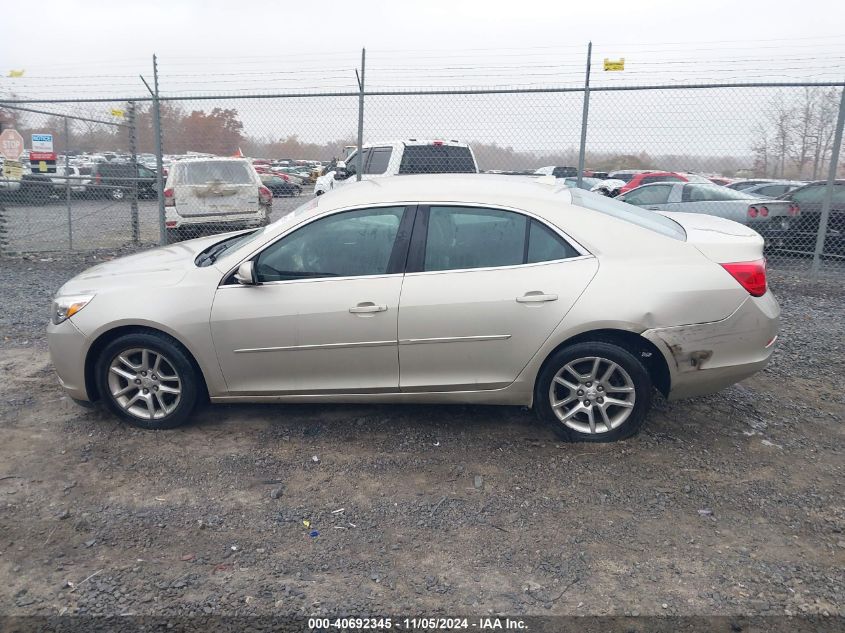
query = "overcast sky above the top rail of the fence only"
(0, 0, 845, 96)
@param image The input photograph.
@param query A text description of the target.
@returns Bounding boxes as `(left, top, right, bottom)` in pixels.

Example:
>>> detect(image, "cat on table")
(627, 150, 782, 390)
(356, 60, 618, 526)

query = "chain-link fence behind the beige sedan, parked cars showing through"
(0, 67, 845, 272)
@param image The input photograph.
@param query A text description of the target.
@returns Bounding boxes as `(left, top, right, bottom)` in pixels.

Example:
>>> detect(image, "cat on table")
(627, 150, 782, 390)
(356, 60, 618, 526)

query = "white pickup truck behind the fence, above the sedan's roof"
(314, 138, 478, 196)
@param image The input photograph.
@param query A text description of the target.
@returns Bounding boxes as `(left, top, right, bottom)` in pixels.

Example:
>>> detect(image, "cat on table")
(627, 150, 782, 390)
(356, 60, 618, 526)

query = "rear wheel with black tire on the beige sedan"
(534, 341, 653, 442)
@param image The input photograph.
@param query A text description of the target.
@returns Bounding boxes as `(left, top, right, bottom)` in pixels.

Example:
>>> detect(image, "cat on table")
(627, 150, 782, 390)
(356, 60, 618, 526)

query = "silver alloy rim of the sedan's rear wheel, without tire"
(549, 356, 636, 434)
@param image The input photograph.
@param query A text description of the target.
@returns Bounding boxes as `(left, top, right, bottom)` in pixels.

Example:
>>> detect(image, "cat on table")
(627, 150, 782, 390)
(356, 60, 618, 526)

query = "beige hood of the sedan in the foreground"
(57, 235, 226, 295)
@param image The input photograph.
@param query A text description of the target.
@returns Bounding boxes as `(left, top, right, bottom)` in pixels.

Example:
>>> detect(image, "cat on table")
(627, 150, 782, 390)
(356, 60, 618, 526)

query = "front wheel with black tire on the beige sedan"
(94, 332, 205, 429)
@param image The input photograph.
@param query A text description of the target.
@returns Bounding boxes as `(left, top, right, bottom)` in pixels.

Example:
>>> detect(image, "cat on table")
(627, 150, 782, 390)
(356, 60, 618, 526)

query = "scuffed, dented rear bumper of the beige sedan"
(643, 291, 780, 400)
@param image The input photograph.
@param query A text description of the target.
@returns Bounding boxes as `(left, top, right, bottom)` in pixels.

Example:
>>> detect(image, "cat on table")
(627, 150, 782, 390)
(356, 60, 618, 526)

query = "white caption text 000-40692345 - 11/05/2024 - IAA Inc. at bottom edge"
(308, 617, 528, 631)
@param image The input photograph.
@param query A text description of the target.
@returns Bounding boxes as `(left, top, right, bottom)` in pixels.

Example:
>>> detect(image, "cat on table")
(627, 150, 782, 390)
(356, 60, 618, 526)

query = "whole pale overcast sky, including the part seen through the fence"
(0, 0, 845, 158)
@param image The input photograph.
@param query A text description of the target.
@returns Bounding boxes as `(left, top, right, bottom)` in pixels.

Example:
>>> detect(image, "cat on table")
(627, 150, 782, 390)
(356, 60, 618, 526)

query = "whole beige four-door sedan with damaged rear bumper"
(48, 174, 780, 442)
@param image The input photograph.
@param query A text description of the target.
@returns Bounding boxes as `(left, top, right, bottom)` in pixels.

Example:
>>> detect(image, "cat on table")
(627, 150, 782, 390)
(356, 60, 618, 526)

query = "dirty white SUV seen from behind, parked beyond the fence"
(164, 158, 273, 242)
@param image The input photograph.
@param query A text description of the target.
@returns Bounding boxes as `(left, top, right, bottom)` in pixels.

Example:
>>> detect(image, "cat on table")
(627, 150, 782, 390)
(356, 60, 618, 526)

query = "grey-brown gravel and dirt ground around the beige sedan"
(0, 251, 845, 616)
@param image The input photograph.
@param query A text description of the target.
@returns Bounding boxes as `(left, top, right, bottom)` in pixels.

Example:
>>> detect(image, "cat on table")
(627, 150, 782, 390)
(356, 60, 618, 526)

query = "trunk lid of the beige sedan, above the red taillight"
(662, 212, 763, 264)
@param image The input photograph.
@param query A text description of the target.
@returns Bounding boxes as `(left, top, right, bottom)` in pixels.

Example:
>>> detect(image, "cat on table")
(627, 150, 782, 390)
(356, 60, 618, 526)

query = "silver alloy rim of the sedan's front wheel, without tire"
(108, 348, 182, 420)
